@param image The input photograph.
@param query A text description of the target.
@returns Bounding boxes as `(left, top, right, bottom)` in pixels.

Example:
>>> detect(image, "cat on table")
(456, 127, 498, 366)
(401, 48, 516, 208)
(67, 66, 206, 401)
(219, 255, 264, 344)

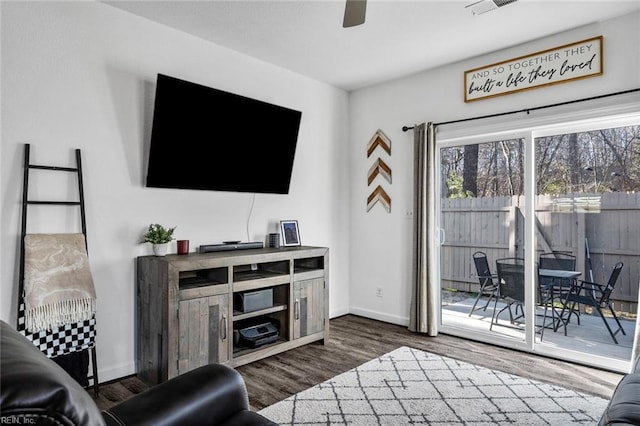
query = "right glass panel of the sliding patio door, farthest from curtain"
(534, 122, 640, 365)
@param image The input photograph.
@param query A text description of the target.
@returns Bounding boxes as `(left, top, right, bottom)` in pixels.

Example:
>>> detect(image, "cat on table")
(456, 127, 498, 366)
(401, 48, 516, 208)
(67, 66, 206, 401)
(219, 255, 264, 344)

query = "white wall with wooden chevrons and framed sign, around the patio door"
(349, 13, 640, 325)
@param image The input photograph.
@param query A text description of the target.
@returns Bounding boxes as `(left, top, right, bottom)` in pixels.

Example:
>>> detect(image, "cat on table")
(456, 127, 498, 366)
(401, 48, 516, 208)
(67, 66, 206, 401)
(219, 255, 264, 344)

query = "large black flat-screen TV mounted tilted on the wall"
(146, 74, 302, 194)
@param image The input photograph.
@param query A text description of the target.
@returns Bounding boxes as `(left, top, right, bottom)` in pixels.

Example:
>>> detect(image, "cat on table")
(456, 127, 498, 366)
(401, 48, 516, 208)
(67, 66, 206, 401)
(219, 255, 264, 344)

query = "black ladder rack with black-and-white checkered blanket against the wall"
(17, 144, 99, 397)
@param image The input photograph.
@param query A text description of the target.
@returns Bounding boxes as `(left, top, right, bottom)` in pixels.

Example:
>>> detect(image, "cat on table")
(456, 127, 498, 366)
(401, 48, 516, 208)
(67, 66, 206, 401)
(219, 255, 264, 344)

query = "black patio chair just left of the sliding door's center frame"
(489, 257, 524, 330)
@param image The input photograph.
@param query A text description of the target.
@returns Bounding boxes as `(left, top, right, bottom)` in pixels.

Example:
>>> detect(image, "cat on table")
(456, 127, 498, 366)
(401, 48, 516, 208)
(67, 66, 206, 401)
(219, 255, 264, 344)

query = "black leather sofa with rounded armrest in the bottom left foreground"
(0, 321, 277, 426)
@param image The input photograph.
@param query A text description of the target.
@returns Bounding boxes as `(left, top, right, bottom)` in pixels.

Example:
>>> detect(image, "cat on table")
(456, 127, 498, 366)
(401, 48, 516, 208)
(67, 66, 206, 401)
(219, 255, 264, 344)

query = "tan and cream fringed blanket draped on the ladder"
(24, 234, 96, 332)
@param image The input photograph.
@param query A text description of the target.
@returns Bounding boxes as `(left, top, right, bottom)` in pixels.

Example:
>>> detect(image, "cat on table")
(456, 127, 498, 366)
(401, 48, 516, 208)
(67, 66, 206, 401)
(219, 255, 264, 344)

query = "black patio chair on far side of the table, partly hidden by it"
(538, 251, 579, 341)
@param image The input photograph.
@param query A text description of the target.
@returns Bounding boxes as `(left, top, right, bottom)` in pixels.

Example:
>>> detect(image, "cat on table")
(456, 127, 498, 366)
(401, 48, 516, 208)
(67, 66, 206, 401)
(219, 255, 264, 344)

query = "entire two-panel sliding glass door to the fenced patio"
(436, 114, 640, 371)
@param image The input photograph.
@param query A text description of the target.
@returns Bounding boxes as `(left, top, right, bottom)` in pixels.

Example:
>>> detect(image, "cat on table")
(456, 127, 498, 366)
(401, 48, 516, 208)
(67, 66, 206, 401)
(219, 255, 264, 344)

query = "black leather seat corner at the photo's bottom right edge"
(598, 355, 640, 426)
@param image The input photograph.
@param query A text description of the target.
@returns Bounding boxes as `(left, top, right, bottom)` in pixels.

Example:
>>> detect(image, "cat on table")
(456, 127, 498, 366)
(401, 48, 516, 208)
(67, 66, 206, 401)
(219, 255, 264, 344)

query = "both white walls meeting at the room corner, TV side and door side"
(0, 2, 640, 380)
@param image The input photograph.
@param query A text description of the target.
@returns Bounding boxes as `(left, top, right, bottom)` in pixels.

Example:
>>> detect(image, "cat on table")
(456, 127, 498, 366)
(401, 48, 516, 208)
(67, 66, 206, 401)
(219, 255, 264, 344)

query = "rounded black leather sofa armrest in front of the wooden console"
(103, 364, 254, 426)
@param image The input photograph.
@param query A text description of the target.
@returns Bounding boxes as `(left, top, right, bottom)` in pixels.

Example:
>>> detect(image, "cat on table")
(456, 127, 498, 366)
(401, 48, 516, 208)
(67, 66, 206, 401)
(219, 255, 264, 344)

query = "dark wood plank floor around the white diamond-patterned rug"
(96, 315, 622, 411)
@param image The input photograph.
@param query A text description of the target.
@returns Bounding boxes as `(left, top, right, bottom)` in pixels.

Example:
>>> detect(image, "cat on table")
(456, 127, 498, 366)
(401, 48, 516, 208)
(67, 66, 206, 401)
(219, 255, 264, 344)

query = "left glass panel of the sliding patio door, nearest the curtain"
(439, 135, 528, 345)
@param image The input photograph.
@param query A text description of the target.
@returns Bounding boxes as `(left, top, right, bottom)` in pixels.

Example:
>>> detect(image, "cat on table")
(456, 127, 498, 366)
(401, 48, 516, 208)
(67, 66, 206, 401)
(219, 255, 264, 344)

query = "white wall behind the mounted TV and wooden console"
(0, 2, 349, 381)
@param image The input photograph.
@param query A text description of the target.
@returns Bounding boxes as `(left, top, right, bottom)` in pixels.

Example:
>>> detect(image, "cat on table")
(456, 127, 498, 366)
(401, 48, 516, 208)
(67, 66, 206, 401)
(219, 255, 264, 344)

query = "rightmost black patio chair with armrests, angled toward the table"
(561, 262, 627, 345)
